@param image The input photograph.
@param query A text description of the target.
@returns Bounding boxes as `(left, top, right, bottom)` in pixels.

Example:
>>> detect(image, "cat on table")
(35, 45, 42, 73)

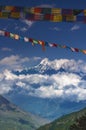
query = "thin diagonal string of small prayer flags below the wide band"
(0, 30, 86, 54)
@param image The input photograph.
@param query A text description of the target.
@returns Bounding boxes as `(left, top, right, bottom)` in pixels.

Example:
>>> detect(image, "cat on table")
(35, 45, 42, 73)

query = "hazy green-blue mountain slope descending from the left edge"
(0, 95, 45, 130)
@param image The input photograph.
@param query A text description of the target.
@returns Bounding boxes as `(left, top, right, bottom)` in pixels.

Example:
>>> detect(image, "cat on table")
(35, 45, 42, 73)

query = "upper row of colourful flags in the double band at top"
(0, 6, 85, 15)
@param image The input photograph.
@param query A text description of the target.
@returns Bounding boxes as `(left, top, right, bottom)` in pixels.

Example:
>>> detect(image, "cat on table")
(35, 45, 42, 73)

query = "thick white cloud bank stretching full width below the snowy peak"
(0, 70, 86, 102)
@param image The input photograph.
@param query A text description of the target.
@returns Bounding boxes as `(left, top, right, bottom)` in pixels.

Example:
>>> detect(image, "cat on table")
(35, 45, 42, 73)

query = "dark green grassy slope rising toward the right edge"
(37, 108, 86, 130)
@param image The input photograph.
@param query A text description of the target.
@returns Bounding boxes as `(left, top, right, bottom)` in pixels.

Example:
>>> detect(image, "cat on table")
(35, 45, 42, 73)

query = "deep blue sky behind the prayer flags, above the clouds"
(0, 0, 86, 60)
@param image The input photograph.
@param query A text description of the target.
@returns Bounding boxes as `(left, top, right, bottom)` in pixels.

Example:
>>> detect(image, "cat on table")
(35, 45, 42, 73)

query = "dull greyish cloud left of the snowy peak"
(0, 55, 41, 70)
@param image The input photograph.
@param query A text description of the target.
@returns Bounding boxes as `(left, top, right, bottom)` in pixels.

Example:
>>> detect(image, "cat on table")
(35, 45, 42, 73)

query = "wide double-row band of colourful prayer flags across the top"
(0, 6, 86, 23)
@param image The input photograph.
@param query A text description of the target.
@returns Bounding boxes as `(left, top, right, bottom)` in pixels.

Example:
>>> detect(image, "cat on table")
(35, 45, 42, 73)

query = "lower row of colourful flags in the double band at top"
(0, 12, 86, 23)
